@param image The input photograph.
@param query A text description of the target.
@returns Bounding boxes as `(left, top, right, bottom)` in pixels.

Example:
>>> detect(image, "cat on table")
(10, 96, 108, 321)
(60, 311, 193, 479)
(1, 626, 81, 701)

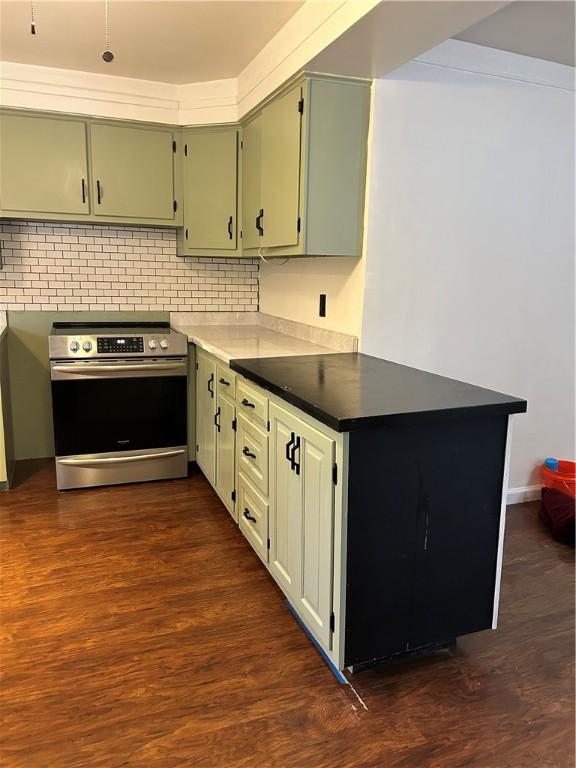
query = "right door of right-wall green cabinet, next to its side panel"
(260, 85, 302, 248)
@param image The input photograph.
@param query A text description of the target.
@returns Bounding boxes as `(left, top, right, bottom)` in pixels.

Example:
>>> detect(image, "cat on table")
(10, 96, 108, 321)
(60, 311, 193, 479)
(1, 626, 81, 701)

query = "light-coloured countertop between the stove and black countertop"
(172, 321, 335, 363)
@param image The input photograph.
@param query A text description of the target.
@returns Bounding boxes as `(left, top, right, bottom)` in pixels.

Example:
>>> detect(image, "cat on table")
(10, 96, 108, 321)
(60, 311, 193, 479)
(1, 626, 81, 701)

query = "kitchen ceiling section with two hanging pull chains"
(0, 0, 304, 83)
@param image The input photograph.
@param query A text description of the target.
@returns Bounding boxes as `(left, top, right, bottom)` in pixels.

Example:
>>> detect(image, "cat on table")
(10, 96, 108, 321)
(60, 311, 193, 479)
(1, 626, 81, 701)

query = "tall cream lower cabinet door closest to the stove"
(196, 350, 216, 486)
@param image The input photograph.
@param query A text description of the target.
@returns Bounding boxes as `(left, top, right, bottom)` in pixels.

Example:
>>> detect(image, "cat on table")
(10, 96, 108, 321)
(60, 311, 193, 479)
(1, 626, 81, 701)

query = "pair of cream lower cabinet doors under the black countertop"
(268, 403, 335, 649)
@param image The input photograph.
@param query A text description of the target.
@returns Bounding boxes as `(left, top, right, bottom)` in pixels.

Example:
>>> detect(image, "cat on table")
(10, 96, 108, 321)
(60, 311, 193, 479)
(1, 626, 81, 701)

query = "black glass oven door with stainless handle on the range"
(50, 358, 187, 457)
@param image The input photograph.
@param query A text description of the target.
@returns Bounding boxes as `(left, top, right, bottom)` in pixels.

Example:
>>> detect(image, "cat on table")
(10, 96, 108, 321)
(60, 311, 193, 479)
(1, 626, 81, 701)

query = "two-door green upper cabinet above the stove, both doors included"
(0, 109, 182, 226)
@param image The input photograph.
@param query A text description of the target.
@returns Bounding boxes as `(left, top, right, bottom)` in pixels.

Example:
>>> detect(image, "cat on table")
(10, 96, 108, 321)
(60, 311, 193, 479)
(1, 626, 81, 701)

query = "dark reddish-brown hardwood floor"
(0, 462, 574, 768)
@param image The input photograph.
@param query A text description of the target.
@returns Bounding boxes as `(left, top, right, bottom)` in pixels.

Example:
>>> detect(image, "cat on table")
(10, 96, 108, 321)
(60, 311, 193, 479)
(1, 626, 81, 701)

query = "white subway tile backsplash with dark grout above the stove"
(0, 221, 258, 312)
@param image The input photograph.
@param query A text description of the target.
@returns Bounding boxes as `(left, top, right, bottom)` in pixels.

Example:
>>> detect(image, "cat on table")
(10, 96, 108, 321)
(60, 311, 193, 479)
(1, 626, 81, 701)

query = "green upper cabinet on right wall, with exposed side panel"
(242, 75, 370, 258)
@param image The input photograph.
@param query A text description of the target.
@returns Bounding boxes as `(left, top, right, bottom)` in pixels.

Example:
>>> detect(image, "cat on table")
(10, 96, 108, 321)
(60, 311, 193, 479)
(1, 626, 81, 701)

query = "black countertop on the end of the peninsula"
(230, 352, 527, 432)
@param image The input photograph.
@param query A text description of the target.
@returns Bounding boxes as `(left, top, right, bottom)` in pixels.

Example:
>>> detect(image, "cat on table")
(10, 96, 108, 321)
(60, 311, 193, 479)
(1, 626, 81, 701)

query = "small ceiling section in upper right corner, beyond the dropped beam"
(455, 0, 575, 67)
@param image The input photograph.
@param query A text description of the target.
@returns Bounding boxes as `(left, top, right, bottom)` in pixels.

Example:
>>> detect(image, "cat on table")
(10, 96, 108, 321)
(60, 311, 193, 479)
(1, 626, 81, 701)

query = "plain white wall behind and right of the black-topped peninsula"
(361, 43, 574, 500)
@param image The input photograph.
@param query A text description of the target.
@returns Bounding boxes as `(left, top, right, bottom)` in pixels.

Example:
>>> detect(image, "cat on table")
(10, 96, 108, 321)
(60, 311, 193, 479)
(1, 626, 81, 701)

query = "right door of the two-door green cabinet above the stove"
(90, 124, 175, 221)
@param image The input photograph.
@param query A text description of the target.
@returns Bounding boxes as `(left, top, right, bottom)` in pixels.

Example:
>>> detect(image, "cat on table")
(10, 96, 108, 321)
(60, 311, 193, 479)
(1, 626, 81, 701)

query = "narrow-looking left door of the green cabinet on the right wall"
(242, 116, 263, 249)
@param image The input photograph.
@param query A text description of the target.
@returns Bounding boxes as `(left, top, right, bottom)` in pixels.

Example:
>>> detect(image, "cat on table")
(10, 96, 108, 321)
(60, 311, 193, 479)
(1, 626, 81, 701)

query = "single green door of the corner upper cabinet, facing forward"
(184, 130, 238, 251)
